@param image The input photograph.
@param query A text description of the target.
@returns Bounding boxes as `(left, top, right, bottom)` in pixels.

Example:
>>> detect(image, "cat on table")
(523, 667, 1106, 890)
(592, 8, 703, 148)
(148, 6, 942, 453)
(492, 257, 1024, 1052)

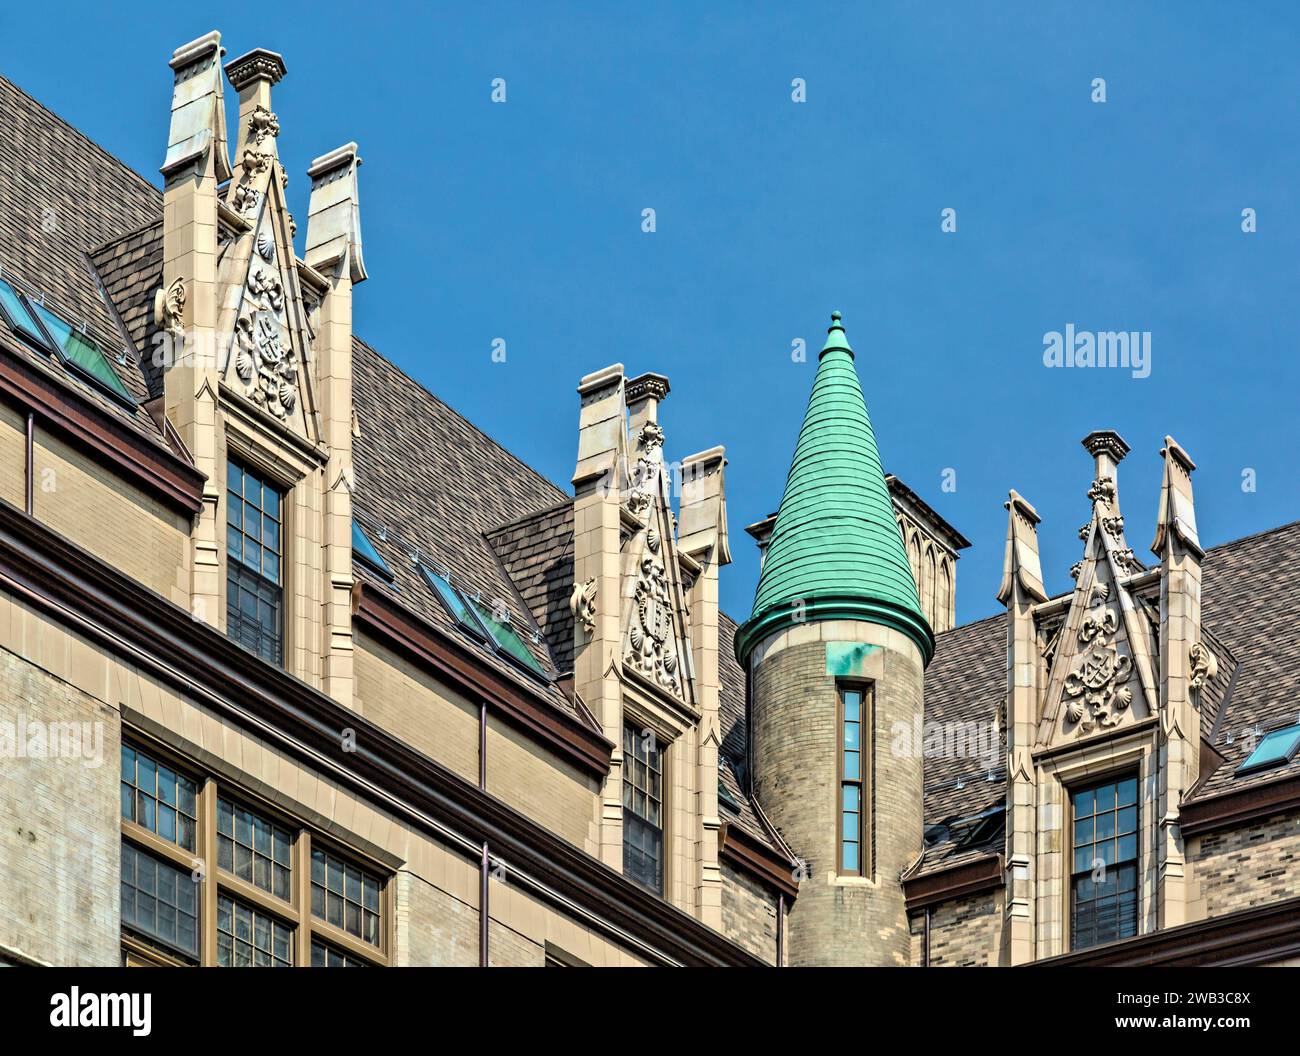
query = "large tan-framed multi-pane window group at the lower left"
(121, 740, 390, 968)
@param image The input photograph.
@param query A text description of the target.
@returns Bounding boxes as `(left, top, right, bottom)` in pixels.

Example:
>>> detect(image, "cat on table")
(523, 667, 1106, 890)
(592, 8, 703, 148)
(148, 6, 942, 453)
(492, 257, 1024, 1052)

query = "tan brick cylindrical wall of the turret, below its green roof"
(753, 623, 922, 965)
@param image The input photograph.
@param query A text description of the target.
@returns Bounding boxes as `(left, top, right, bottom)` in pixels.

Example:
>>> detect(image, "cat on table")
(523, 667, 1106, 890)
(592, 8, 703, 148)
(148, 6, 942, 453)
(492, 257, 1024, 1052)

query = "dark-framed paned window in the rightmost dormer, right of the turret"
(1070, 776, 1138, 949)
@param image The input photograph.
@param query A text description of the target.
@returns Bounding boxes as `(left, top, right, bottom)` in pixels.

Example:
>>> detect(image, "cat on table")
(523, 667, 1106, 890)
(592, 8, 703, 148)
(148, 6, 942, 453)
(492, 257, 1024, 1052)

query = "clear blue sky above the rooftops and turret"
(0, 0, 1300, 622)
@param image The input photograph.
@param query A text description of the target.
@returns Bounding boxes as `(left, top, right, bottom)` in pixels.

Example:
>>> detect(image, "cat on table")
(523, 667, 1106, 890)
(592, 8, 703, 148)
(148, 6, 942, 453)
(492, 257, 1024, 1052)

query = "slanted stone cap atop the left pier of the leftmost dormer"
(161, 30, 230, 182)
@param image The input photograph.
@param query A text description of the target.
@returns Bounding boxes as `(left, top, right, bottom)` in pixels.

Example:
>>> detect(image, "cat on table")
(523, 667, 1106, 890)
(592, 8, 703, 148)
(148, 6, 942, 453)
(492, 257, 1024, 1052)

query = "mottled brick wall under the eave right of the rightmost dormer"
(1187, 812, 1300, 917)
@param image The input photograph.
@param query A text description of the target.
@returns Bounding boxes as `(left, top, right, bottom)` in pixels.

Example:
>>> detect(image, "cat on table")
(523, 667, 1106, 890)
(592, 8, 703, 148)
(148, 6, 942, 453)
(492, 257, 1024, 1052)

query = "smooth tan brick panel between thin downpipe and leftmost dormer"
(31, 429, 190, 603)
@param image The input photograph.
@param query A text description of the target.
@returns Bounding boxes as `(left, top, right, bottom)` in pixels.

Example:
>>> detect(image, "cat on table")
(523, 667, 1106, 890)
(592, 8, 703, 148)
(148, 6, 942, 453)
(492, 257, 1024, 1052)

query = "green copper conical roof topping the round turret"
(736, 312, 935, 665)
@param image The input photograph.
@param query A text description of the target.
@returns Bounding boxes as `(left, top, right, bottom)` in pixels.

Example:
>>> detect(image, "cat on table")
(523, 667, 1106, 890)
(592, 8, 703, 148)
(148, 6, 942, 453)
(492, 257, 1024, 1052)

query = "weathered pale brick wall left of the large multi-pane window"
(0, 642, 121, 965)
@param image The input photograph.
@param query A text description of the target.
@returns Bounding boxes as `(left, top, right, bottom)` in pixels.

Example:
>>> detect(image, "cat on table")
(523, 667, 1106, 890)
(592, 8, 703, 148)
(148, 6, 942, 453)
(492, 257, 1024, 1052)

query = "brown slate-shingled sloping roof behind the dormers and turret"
(0, 64, 1300, 889)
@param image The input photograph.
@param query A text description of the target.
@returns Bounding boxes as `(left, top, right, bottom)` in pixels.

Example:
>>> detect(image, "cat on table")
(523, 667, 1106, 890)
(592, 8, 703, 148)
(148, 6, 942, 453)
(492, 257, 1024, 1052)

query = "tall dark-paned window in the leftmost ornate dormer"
(226, 462, 285, 663)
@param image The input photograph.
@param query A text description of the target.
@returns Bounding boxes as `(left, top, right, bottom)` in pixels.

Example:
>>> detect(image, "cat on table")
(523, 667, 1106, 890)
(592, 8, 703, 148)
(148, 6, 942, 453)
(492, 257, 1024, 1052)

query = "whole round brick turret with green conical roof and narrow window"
(736, 312, 935, 965)
